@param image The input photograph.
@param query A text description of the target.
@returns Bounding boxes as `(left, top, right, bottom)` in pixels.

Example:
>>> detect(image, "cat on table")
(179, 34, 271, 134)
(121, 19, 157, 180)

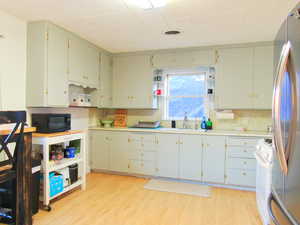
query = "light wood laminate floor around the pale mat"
(34, 173, 261, 225)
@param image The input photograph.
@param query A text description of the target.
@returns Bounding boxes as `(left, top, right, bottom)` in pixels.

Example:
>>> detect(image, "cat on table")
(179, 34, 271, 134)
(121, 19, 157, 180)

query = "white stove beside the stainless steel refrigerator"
(255, 139, 273, 225)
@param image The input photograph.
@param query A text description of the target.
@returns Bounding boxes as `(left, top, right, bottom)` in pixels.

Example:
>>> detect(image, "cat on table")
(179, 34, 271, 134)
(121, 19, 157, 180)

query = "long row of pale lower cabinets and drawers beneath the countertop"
(90, 130, 258, 187)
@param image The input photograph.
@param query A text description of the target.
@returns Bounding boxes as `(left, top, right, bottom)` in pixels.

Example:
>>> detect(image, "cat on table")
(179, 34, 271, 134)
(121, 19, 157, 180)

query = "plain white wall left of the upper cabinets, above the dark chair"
(0, 11, 27, 110)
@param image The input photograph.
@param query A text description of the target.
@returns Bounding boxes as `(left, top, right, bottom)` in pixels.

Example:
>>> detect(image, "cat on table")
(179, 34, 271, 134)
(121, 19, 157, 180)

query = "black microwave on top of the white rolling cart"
(31, 113, 71, 133)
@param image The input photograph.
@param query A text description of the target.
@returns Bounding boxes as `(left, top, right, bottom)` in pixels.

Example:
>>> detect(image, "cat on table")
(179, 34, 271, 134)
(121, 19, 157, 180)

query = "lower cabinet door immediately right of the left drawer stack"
(157, 134, 179, 178)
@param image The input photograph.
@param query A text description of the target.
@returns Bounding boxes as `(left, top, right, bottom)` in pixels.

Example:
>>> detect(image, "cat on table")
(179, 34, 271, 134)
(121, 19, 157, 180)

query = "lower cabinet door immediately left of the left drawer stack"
(110, 132, 128, 172)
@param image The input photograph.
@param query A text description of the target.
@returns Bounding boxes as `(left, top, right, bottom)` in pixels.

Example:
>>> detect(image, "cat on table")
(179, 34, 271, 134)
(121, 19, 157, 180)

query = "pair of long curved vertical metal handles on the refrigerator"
(273, 42, 297, 174)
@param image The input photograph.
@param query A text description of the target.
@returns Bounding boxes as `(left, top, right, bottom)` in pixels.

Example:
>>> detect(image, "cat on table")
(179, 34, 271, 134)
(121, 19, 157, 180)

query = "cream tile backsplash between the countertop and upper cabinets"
(95, 109, 272, 131)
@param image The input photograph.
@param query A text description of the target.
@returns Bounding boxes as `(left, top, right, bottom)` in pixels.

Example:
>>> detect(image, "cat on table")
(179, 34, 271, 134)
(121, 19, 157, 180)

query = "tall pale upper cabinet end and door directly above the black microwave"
(26, 22, 69, 107)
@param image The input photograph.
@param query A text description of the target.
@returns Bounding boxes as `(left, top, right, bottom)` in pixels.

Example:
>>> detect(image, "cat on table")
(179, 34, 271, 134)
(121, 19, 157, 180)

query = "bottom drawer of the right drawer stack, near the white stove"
(226, 169, 256, 187)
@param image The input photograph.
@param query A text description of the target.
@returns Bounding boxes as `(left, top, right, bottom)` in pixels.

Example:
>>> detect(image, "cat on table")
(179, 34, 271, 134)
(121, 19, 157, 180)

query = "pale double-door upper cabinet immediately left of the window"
(113, 55, 157, 109)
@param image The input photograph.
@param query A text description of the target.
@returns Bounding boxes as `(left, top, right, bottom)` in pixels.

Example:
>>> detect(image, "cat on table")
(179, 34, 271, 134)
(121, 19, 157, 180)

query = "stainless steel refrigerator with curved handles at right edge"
(268, 3, 300, 225)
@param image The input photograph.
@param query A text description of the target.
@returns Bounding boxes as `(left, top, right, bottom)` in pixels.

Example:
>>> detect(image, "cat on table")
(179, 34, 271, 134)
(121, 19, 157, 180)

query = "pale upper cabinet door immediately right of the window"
(216, 48, 253, 109)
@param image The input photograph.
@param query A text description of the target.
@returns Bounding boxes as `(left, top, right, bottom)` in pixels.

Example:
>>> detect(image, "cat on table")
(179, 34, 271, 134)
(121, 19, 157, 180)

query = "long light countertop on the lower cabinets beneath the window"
(89, 127, 272, 138)
